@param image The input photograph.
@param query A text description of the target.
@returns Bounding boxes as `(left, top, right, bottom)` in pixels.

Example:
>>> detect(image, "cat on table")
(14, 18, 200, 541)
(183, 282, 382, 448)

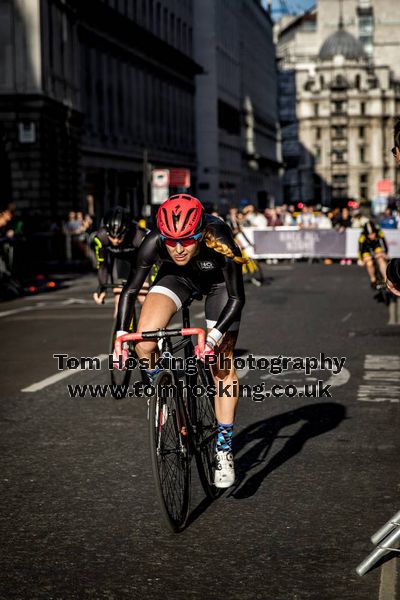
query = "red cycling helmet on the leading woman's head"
(157, 194, 205, 239)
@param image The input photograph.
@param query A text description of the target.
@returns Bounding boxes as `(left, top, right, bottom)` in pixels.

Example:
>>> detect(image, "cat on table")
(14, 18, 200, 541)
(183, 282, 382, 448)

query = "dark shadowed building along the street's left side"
(0, 0, 202, 217)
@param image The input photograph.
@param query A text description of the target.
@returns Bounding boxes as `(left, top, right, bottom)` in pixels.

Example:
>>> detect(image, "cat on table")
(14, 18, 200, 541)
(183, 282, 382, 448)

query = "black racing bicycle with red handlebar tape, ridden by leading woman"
(116, 298, 220, 532)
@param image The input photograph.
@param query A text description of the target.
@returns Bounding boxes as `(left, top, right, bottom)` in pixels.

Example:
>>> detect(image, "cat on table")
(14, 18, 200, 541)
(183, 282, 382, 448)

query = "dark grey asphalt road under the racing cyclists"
(0, 264, 400, 600)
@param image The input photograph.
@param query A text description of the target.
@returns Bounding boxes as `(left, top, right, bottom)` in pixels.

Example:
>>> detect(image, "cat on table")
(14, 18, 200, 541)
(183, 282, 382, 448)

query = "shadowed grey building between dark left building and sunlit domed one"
(194, 0, 281, 209)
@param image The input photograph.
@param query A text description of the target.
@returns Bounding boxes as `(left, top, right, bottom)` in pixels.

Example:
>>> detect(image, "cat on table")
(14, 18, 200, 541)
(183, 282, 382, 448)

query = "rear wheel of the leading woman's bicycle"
(189, 363, 221, 499)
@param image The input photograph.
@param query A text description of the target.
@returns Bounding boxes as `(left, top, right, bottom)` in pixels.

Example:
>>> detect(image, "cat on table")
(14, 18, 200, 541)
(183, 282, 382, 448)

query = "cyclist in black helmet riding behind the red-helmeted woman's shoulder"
(92, 206, 148, 313)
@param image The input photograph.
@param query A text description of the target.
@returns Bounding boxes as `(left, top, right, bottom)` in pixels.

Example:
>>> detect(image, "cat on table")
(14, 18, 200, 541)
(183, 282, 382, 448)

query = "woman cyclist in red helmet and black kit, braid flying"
(115, 194, 246, 488)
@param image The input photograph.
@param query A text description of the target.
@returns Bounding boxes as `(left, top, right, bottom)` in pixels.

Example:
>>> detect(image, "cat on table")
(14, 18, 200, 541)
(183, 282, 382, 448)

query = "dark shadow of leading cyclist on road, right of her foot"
(229, 402, 346, 500)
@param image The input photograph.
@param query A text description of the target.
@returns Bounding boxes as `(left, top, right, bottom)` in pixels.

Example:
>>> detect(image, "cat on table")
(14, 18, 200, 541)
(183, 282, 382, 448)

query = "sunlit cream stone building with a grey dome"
(276, 0, 400, 205)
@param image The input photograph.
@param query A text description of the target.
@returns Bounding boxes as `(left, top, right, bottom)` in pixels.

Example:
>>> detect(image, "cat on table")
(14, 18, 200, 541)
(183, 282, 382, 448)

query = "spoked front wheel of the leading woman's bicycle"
(149, 371, 191, 532)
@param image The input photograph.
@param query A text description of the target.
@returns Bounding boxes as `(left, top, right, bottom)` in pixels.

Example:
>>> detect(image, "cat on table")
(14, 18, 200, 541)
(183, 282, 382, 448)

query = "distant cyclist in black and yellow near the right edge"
(358, 220, 388, 289)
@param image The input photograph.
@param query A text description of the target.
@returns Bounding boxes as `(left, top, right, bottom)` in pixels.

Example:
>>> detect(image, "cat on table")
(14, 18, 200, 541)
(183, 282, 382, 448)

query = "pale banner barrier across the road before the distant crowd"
(243, 227, 400, 259)
